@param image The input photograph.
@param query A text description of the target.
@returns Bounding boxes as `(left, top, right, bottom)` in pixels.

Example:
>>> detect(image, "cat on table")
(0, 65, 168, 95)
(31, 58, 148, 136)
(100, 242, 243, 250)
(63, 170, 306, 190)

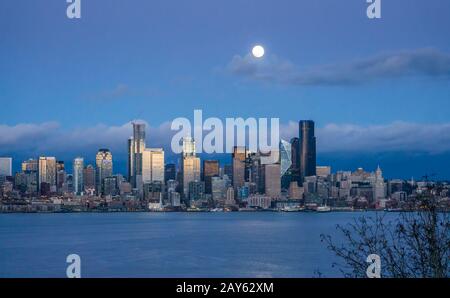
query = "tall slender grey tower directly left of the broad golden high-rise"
(128, 123, 145, 190)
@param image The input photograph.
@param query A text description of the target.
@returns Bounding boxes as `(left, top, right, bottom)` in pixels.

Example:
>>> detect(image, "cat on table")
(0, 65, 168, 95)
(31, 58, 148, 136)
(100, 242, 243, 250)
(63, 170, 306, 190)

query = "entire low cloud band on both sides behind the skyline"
(0, 120, 450, 163)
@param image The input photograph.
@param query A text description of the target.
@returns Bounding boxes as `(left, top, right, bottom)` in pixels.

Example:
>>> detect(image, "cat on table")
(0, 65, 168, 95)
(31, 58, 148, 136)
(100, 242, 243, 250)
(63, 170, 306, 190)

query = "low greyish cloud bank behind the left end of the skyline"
(0, 120, 173, 159)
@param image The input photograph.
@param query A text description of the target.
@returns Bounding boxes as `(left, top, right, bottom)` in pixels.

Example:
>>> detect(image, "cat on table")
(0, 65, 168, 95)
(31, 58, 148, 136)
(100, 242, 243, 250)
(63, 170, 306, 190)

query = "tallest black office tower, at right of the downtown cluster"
(299, 120, 316, 182)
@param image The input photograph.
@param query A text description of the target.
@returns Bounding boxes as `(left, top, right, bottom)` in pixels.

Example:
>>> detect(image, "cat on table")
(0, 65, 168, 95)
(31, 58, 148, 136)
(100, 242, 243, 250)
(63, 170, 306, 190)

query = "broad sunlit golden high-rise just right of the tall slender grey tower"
(142, 148, 164, 183)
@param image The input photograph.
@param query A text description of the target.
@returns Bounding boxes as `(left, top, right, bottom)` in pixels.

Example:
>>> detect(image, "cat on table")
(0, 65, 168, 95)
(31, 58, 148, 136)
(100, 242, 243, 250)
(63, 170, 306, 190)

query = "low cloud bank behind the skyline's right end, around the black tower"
(281, 121, 450, 154)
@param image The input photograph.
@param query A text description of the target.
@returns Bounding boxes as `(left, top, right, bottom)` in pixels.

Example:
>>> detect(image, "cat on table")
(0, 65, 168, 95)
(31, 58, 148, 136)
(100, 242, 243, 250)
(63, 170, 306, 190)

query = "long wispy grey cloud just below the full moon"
(226, 48, 450, 85)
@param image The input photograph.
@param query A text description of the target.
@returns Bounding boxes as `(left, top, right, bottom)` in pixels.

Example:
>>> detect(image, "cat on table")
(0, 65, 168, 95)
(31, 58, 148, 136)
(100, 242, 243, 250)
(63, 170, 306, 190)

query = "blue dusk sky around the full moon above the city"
(0, 0, 450, 178)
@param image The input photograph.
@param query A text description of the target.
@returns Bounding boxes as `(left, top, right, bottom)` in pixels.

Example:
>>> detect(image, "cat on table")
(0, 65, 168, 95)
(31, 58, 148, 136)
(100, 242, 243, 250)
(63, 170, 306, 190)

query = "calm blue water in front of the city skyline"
(0, 212, 378, 277)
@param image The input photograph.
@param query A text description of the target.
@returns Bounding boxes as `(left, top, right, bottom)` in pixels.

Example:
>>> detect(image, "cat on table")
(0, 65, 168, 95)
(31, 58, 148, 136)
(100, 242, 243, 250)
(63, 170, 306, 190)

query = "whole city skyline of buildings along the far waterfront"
(0, 116, 449, 212)
